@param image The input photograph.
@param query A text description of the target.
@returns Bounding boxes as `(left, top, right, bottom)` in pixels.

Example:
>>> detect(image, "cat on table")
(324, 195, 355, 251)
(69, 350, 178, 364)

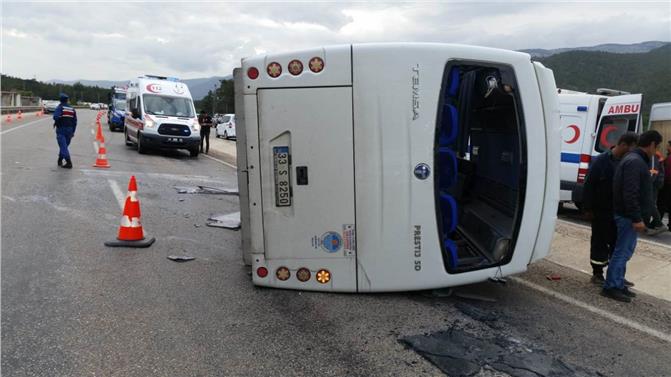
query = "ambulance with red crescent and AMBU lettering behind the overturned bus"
(558, 88, 643, 208)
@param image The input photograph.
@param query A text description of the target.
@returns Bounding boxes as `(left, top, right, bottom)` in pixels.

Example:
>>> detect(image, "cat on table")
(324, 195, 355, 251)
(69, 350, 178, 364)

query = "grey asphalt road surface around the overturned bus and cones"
(0, 110, 671, 377)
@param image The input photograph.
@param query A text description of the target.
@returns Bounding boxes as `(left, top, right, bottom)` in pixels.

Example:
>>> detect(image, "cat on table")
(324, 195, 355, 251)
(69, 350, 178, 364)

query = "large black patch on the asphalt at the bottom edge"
(400, 328, 598, 377)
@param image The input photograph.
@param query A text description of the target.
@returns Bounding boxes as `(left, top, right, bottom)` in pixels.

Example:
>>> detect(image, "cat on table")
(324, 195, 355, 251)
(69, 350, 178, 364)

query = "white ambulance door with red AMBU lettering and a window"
(593, 94, 643, 154)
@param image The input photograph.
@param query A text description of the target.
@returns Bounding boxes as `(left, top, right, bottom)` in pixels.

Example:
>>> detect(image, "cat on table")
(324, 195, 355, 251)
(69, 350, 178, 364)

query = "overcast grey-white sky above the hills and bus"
(0, 0, 671, 80)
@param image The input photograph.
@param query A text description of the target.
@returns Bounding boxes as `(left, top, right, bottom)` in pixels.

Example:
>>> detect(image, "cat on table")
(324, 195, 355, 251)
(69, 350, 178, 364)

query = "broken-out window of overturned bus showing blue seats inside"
(434, 61, 526, 273)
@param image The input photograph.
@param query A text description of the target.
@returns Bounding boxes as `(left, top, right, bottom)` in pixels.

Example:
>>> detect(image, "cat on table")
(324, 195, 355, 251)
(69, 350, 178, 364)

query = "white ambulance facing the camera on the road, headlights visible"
(124, 75, 200, 157)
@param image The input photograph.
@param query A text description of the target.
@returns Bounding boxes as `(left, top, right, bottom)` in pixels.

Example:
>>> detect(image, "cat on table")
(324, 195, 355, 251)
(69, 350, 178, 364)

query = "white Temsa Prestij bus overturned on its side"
(234, 43, 560, 292)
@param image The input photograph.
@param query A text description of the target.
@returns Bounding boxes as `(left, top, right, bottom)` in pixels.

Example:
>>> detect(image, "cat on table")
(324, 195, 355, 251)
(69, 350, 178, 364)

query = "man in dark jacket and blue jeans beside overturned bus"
(601, 130, 662, 302)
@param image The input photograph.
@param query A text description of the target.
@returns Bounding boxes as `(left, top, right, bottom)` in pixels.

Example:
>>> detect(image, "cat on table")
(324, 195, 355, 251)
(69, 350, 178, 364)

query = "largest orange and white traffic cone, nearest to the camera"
(105, 176, 156, 247)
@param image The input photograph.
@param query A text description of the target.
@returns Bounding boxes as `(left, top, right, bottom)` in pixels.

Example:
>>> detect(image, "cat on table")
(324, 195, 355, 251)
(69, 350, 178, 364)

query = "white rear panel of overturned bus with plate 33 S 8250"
(258, 86, 356, 291)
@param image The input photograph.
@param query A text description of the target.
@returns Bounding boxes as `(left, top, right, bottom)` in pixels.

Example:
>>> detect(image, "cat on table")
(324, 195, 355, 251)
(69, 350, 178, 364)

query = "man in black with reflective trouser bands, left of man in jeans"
(583, 132, 638, 286)
